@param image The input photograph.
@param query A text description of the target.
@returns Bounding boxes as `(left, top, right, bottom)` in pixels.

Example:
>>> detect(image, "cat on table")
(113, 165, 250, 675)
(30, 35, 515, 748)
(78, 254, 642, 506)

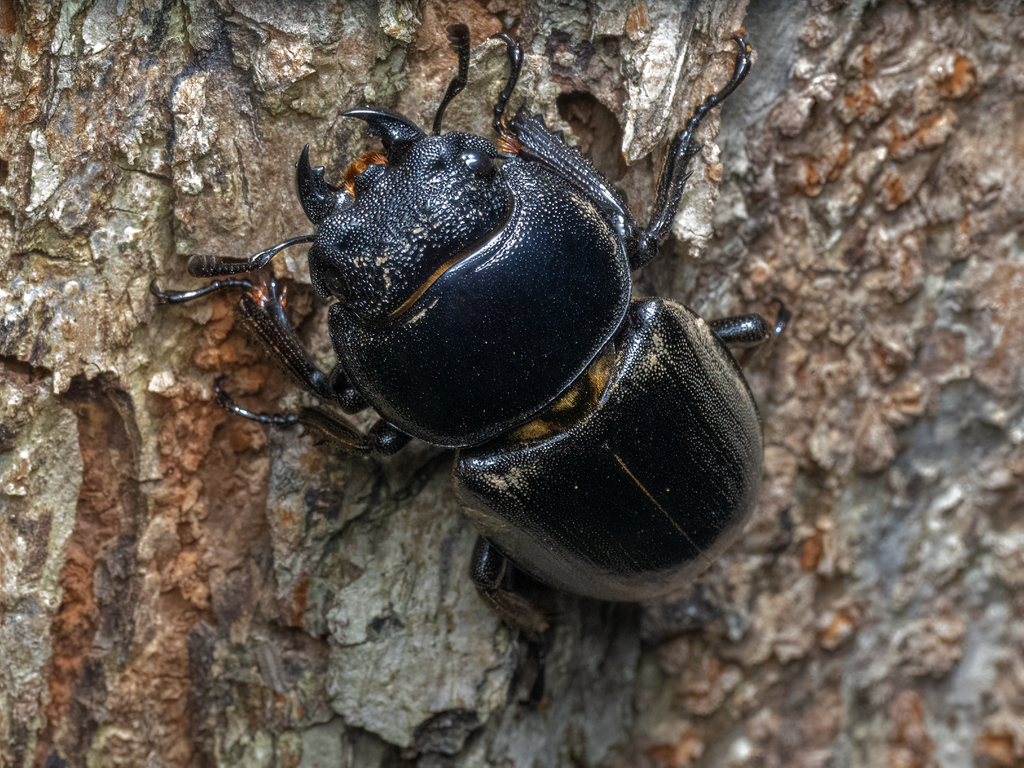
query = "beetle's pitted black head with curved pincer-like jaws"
(298, 123, 512, 321)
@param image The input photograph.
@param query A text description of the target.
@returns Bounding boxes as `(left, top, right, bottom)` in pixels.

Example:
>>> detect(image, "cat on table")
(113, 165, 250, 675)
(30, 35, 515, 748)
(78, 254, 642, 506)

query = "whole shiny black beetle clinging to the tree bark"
(153, 25, 784, 633)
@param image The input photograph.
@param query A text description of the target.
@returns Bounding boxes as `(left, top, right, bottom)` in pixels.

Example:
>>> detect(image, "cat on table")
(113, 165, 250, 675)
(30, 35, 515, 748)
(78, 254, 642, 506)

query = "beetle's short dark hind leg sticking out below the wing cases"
(469, 536, 548, 641)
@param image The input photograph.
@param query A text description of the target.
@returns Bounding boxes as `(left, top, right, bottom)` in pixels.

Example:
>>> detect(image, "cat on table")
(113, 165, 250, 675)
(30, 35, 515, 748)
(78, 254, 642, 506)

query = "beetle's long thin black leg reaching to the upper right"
(630, 36, 753, 270)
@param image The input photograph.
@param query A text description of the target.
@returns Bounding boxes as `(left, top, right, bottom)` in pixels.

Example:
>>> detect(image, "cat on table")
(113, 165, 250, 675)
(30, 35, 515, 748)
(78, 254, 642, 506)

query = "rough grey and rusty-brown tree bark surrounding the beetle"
(0, 0, 1024, 768)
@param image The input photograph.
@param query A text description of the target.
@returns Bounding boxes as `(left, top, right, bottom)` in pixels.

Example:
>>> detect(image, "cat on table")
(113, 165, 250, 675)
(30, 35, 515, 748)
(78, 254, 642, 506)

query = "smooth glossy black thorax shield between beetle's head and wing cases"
(331, 161, 630, 446)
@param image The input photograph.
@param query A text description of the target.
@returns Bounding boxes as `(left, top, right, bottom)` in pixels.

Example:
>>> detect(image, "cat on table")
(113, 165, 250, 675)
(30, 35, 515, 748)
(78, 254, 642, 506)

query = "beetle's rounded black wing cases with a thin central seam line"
(454, 299, 762, 601)
